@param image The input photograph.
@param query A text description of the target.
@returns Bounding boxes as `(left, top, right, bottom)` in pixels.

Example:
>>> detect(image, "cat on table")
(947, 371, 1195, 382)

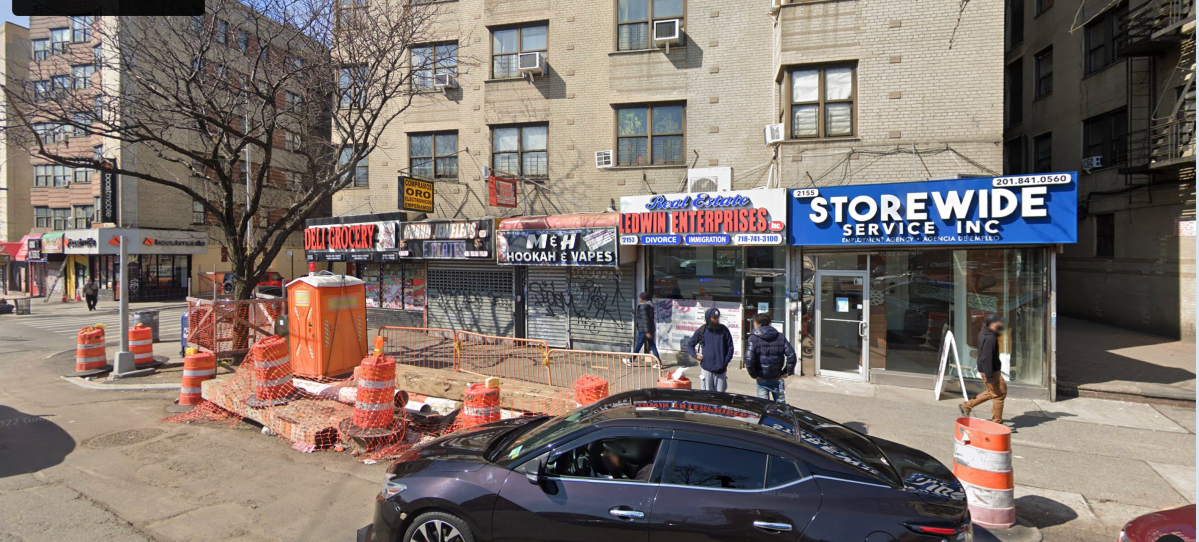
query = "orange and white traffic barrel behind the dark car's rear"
(953, 417, 1016, 529)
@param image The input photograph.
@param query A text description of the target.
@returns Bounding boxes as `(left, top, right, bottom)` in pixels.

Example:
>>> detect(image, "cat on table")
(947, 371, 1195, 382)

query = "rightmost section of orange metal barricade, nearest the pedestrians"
(548, 349, 662, 395)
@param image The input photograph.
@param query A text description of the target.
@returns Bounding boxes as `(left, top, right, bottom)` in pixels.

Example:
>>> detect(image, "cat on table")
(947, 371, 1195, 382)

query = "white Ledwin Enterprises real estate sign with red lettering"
(620, 188, 787, 246)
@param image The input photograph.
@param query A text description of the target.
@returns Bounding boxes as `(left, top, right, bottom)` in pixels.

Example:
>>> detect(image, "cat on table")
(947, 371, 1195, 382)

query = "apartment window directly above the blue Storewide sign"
(789, 66, 857, 138)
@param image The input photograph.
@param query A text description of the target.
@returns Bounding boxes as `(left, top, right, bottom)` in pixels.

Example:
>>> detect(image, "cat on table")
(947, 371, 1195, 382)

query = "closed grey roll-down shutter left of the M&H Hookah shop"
(427, 261, 516, 337)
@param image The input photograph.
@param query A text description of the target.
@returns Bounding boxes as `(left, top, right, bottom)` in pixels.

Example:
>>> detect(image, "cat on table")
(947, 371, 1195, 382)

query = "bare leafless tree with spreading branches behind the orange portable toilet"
(0, 0, 438, 299)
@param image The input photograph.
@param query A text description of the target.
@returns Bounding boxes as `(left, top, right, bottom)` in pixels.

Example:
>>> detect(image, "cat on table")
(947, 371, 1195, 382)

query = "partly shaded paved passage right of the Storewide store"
(1058, 318, 1195, 408)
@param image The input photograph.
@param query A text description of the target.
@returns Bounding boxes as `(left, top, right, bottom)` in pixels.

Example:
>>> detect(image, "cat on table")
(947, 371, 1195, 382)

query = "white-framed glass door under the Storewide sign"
(815, 271, 870, 380)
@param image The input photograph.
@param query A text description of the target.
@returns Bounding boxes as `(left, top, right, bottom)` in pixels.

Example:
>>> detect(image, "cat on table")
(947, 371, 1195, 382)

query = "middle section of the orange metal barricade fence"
(458, 331, 553, 386)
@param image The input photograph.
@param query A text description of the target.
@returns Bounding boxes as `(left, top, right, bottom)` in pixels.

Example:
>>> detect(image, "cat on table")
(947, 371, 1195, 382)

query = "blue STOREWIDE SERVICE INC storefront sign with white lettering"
(788, 171, 1078, 247)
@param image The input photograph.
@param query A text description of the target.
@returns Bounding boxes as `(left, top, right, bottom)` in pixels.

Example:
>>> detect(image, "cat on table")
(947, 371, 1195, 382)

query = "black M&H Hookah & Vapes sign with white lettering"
(496, 228, 619, 267)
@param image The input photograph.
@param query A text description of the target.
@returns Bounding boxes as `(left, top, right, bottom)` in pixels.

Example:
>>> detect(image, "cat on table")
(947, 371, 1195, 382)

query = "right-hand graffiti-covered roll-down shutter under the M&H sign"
(570, 265, 637, 351)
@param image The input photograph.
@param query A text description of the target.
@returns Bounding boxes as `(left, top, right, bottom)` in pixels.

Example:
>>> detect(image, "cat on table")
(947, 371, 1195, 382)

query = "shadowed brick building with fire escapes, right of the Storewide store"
(1004, 0, 1195, 341)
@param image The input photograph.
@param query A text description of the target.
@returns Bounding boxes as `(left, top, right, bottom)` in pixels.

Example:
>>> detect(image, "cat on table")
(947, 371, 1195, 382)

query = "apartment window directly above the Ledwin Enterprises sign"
(616, 106, 683, 165)
